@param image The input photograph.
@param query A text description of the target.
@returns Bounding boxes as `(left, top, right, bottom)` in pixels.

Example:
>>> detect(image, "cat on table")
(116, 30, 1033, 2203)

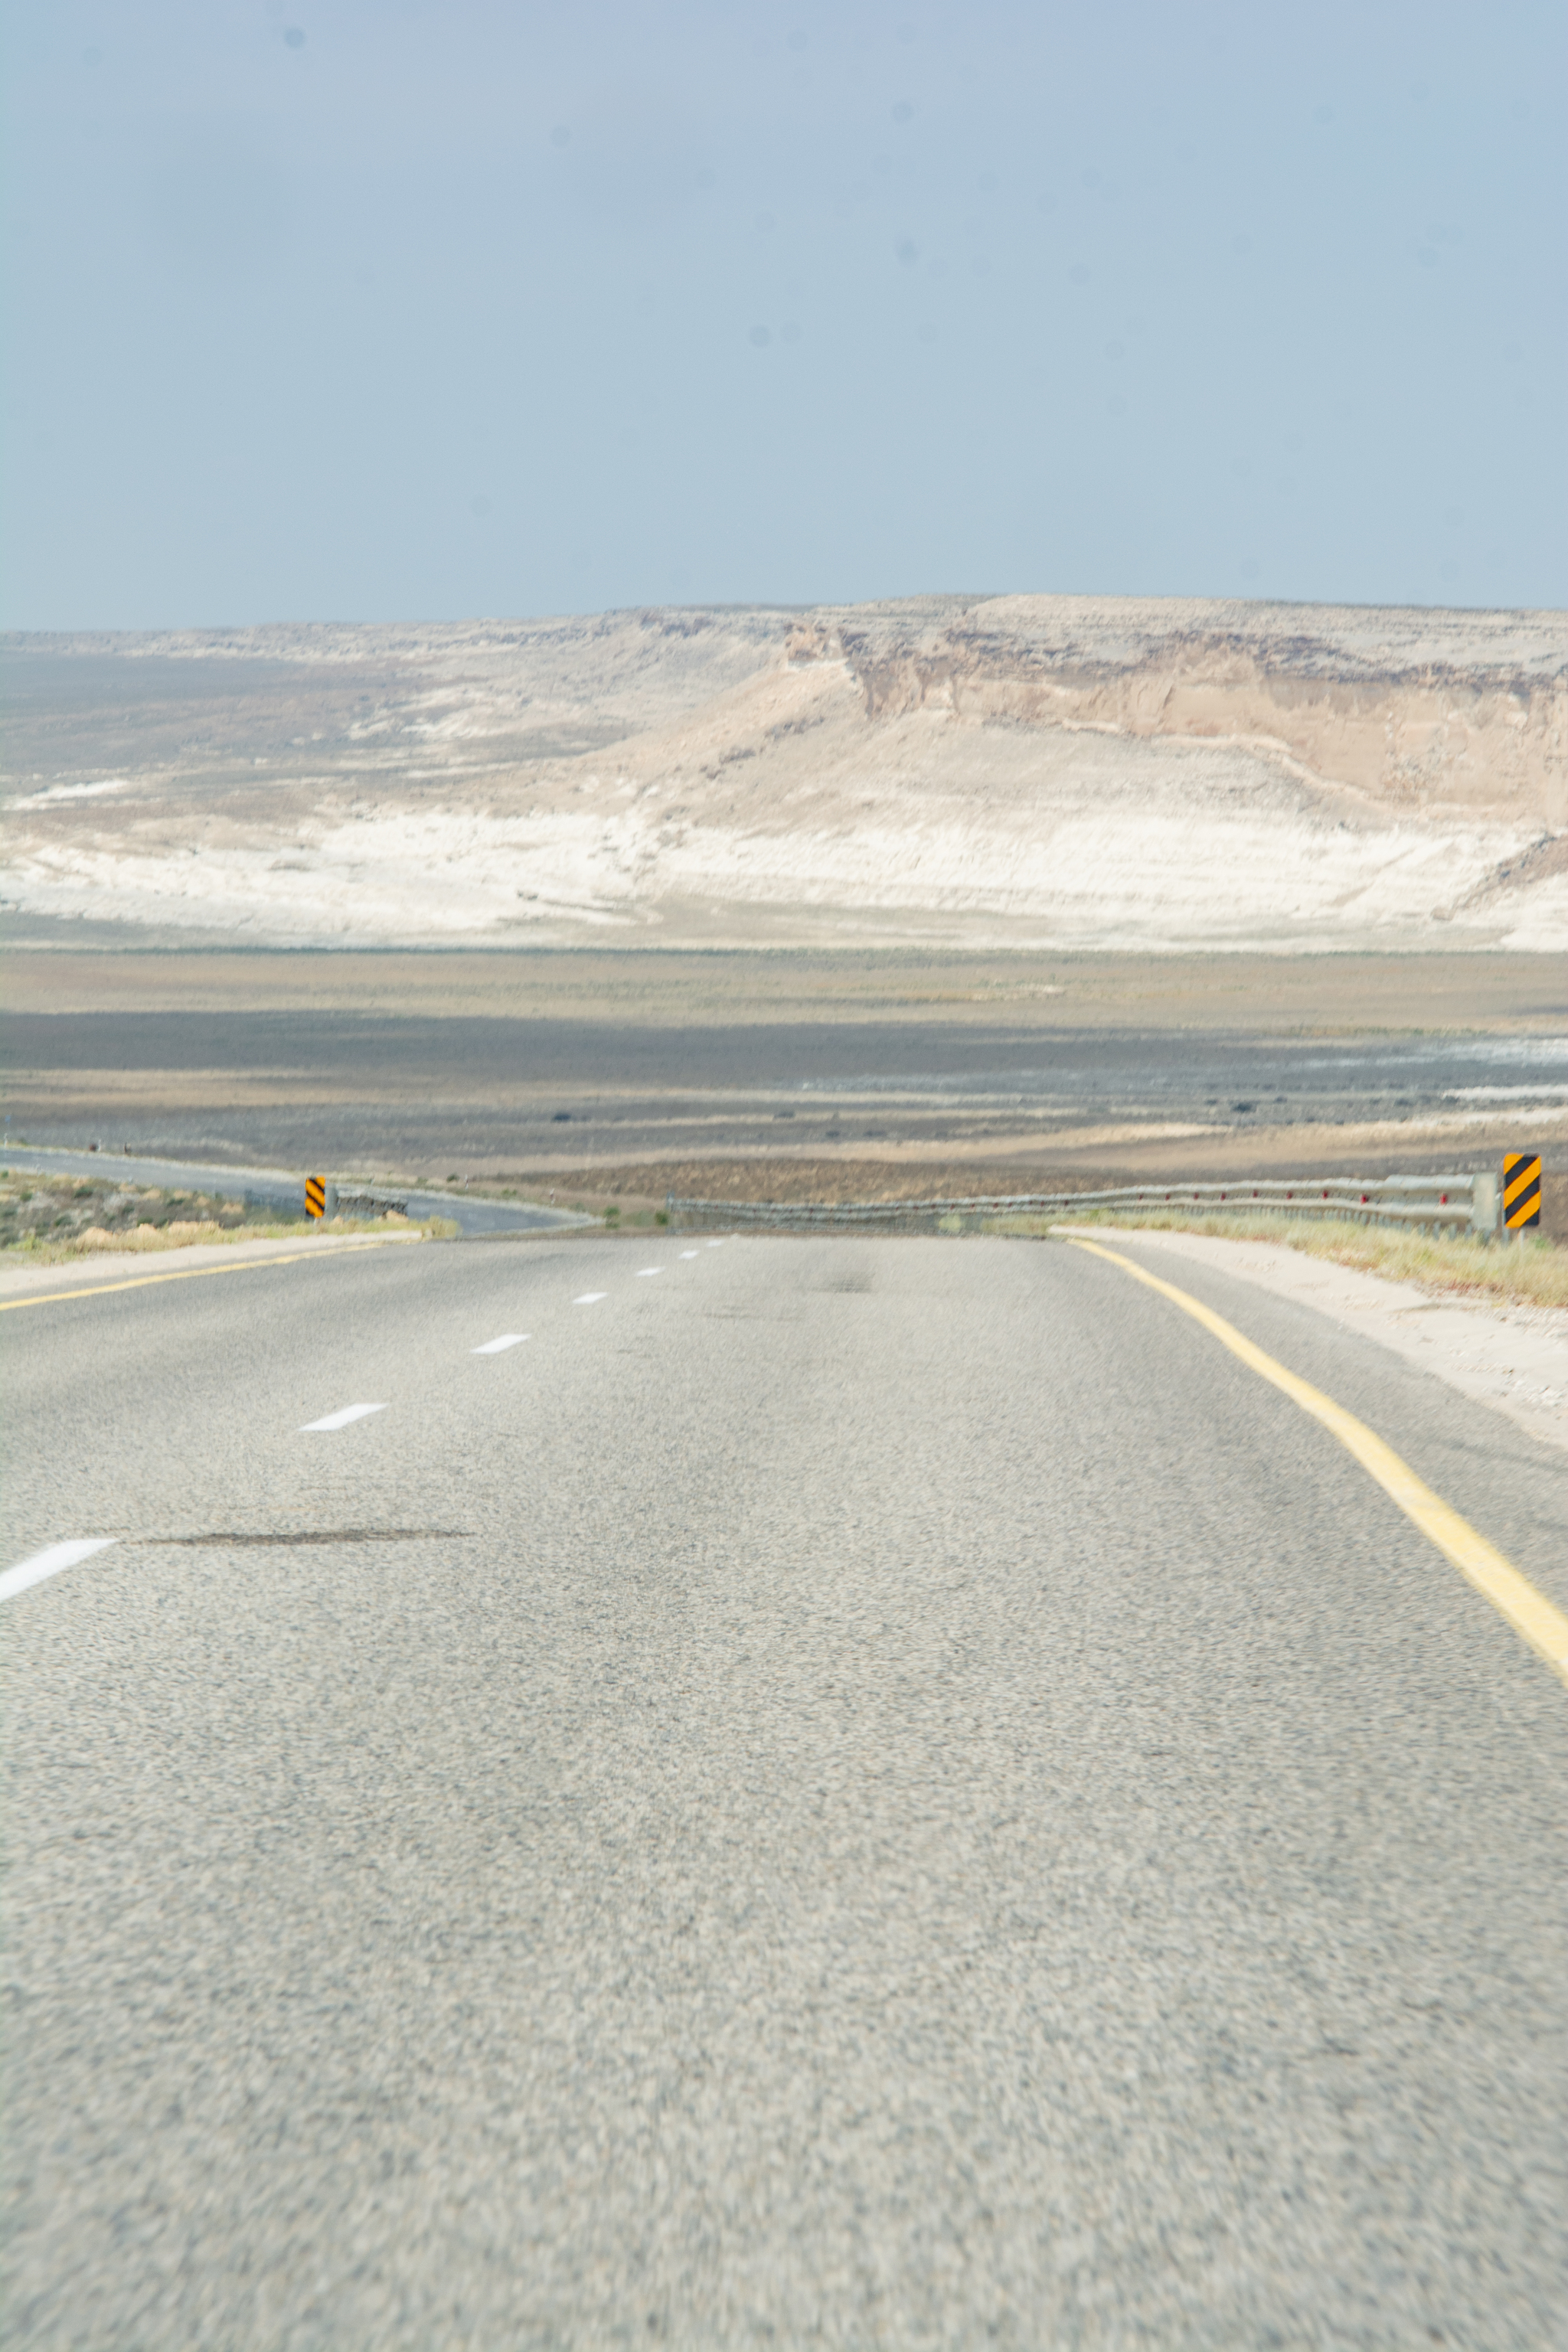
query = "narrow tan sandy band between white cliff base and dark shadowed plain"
(0, 940, 1568, 1037)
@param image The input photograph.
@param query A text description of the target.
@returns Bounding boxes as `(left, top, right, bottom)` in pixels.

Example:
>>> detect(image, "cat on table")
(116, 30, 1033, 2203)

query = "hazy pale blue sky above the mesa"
(0, 0, 1568, 628)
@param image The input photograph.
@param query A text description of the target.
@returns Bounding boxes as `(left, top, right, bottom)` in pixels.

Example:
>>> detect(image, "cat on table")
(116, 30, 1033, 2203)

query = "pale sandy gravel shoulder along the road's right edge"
(1056, 1226, 1568, 1449)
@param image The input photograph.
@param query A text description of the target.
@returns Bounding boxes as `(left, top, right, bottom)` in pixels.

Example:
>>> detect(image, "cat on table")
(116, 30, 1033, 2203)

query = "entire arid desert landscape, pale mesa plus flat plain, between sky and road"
(0, 597, 1568, 1197)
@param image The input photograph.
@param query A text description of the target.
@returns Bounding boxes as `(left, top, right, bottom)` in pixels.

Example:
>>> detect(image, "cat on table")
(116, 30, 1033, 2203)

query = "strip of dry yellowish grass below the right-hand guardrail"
(988, 1209, 1568, 1308)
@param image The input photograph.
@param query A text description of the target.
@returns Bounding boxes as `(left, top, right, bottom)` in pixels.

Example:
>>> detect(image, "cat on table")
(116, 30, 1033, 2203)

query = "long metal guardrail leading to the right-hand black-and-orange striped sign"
(665, 1169, 1500, 1240)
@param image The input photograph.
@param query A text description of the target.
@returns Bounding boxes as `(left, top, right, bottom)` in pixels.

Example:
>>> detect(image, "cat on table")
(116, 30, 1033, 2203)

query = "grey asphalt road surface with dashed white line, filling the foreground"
(0, 1237, 1568, 2352)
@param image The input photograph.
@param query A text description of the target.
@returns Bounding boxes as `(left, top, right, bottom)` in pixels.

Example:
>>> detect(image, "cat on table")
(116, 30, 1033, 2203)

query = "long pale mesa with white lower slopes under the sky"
(0, 597, 1568, 952)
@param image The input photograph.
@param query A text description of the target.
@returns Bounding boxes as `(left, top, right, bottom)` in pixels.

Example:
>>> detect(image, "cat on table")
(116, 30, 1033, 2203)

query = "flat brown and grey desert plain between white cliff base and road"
(0, 948, 1568, 1218)
